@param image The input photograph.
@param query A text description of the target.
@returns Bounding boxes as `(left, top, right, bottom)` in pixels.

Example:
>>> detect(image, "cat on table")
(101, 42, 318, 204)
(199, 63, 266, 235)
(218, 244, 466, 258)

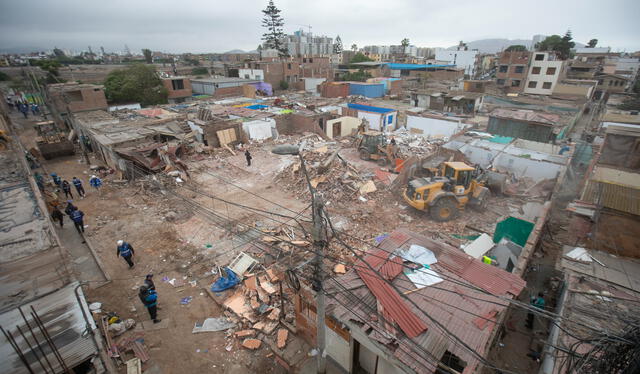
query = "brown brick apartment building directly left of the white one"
(496, 51, 531, 93)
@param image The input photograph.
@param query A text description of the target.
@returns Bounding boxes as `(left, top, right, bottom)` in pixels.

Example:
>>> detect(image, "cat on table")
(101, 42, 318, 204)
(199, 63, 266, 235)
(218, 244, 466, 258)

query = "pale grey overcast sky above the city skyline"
(0, 0, 640, 53)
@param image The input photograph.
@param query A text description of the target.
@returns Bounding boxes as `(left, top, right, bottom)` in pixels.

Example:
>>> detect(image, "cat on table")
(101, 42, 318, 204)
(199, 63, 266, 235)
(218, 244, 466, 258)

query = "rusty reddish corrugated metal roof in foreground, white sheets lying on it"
(327, 230, 525, 373)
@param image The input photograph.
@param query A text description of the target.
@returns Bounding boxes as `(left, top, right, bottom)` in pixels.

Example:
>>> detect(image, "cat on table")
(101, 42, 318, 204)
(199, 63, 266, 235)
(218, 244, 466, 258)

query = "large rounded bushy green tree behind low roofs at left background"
(104, 64, 167, 106)
